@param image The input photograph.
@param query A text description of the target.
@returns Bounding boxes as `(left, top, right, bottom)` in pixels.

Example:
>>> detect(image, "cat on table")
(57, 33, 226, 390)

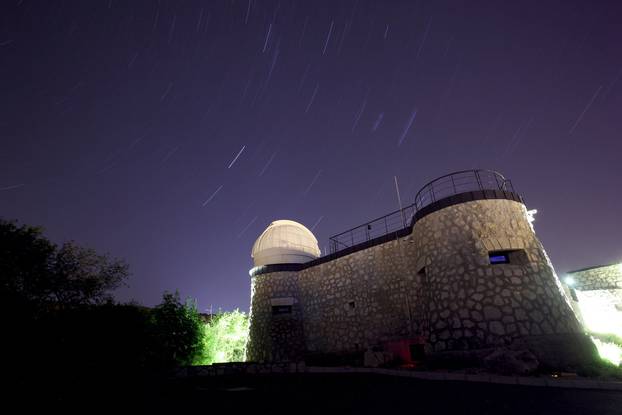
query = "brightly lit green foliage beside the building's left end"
(194, 309, 249, 365)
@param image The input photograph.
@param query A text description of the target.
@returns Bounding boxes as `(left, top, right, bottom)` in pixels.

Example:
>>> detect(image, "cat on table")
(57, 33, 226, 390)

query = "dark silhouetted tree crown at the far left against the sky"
(0, 219, 129, 308)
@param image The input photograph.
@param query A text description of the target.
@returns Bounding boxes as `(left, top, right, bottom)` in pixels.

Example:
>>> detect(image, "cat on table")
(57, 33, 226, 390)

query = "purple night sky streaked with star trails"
(0, 0, 622, 311)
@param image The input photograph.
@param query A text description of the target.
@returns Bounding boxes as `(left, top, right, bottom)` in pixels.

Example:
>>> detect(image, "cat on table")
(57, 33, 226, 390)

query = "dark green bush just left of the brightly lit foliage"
(151, 292, 204, 366)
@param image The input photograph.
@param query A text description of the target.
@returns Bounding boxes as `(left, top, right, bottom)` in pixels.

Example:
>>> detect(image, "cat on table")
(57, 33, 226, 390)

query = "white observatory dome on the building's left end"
(251, 220, 321, 267)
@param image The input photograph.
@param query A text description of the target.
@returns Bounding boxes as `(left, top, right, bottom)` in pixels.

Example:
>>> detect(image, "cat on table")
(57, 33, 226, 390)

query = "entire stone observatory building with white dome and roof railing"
(247, 170, 593, 367)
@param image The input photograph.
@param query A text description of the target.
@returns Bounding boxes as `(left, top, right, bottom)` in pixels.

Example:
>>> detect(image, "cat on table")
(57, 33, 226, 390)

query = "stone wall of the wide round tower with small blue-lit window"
(408, 200, 581, 351)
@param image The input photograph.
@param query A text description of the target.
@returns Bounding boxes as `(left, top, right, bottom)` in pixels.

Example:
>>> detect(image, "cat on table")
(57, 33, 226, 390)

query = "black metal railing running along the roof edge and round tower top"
(329, 170, 514, 254)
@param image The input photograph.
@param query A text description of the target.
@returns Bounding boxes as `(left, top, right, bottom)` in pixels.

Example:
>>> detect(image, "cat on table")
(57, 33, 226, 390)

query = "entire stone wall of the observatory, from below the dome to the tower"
(248, 200, 596, 368)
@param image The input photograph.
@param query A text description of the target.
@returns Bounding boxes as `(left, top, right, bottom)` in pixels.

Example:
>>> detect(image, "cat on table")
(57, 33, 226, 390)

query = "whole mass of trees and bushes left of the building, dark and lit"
(0, 219, 243, 373)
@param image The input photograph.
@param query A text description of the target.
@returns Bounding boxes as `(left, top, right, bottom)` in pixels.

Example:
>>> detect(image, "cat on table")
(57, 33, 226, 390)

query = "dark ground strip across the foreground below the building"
(14, 370, 622, 415)
